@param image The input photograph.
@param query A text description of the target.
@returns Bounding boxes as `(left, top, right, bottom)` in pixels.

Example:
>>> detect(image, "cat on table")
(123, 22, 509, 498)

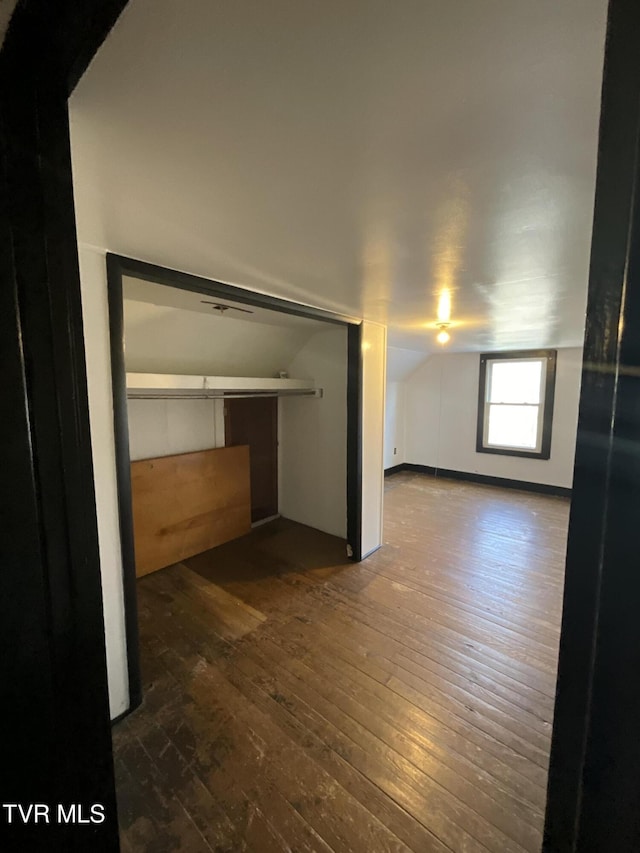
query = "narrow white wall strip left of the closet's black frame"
(78, 245, 129, 719)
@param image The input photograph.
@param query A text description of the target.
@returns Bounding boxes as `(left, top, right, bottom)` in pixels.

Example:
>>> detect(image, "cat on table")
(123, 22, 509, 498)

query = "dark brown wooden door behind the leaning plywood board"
(224, 397, 278, 522)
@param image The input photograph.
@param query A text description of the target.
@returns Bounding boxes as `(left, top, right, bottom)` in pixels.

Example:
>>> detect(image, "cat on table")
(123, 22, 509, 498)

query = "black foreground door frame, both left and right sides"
(0, 0, 640, 853)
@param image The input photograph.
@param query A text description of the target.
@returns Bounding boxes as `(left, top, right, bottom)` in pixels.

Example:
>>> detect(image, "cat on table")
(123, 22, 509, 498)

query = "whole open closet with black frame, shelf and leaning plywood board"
(107, 254, 362, 710)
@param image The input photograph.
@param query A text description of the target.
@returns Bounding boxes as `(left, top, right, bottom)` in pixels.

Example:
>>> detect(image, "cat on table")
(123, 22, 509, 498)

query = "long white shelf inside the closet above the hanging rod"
(127, 373, 322, 400)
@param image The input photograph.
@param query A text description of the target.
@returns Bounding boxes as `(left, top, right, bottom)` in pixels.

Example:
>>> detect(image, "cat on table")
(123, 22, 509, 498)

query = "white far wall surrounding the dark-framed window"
(405, 348, 582, 488)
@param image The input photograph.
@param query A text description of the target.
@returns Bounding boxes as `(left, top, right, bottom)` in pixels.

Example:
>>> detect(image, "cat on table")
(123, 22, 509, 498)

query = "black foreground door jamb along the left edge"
(0, 0, 130, 851)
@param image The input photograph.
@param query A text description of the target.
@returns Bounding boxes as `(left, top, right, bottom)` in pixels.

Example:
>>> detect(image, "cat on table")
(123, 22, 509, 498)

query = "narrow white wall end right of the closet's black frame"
(362, 321, 387, 556)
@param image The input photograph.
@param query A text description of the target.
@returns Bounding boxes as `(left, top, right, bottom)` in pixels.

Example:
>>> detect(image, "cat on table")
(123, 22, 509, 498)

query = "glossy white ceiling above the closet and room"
(71, 0, 607, 351)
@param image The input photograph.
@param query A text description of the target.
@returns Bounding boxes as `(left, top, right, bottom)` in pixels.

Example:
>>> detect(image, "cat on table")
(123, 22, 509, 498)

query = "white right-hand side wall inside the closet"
(279, 327, 347, 538)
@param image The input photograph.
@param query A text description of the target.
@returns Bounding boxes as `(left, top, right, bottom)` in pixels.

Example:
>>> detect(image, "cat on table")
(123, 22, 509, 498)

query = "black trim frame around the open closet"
(107, 253, 362, 713)
